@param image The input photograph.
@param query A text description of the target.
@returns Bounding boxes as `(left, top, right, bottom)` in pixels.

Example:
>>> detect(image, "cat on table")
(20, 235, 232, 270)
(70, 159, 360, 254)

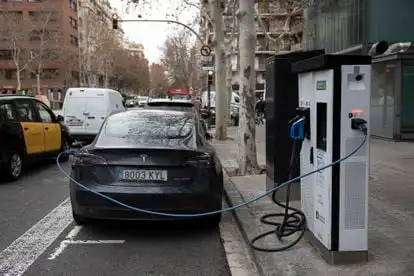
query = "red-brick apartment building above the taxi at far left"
(0, 0, 79, 106)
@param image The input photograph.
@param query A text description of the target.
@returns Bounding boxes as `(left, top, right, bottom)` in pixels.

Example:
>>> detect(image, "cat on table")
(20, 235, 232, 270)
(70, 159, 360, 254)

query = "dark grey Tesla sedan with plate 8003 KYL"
(70, 109, 223, 226)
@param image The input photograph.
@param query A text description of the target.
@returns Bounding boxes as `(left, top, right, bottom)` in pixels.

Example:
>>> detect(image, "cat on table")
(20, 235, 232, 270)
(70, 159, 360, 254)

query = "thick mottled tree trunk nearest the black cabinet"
(239, 0, 259, 175)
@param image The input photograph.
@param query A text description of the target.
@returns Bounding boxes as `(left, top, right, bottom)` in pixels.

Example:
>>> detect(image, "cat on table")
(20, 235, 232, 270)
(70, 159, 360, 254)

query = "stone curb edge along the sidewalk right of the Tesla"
(223, 169, 266, 276)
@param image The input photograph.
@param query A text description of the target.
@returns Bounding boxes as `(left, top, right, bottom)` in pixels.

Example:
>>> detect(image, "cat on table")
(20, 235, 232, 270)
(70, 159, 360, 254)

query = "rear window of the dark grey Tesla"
(96, 110, 195, 147)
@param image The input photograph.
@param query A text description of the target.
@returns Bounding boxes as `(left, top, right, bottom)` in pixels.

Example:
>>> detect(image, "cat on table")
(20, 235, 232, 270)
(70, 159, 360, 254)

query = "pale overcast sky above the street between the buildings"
(110, 0, 197, 64)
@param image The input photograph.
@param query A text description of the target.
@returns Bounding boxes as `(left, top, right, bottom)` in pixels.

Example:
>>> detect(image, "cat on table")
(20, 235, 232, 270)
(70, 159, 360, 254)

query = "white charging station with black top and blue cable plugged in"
(292, 55, 371, 264)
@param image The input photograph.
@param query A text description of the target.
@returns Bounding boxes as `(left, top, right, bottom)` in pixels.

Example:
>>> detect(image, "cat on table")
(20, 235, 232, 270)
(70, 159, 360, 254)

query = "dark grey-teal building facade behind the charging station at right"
(303, 0, 414, 140)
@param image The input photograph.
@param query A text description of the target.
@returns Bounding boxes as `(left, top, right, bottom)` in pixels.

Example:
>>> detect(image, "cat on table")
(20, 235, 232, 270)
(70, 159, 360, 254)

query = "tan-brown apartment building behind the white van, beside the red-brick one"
(78, 0, 124, 87)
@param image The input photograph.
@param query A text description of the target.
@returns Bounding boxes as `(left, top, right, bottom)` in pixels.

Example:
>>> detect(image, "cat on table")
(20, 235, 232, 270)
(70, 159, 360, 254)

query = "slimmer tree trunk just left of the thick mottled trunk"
(212, 0, 228, 140)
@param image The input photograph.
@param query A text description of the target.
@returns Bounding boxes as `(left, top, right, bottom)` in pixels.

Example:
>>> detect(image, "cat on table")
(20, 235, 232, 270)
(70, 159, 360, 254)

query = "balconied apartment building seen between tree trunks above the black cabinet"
(201, 0, 304, 97)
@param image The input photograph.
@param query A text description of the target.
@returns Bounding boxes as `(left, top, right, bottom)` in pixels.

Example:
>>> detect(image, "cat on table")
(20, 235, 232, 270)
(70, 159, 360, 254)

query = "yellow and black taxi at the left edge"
(0, 95, 72, 181)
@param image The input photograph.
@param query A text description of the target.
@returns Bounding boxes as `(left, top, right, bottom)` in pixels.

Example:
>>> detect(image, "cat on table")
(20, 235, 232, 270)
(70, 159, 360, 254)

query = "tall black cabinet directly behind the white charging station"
(266, 50, 325, 200)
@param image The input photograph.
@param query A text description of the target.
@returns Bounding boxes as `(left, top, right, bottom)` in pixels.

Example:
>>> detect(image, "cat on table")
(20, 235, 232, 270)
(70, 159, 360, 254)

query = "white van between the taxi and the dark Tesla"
(62, 88, 126, 141)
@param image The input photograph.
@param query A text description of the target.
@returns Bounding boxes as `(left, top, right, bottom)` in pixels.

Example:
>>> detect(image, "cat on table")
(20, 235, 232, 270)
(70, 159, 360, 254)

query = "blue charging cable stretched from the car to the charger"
(56, 129, 367, 218)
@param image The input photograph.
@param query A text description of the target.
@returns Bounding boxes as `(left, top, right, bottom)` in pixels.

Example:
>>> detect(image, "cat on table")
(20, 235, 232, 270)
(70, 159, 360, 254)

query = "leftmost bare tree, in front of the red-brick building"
(0, 11, 36, 90)
